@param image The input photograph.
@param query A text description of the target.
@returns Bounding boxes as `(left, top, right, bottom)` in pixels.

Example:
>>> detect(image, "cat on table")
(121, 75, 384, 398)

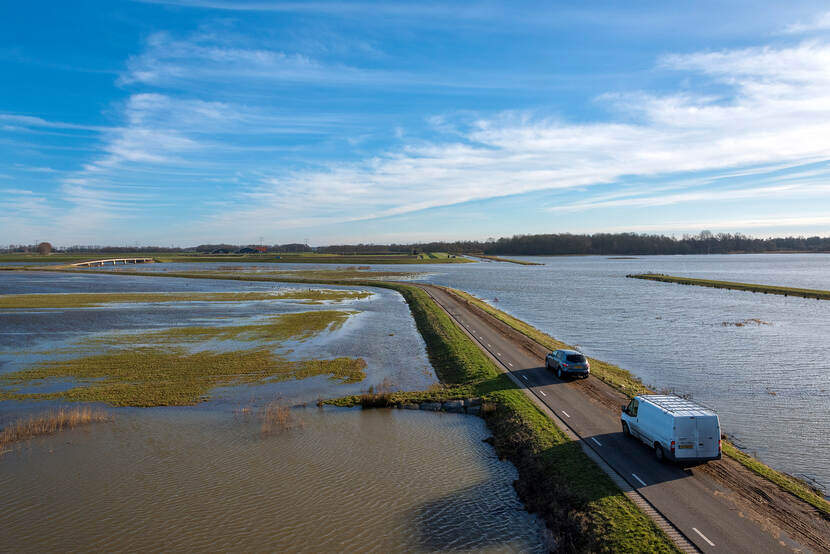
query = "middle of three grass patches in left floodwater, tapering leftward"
(81, 310, 355, 346)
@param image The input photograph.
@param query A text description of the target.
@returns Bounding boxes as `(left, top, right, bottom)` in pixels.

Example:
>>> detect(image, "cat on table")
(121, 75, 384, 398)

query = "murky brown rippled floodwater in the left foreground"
(0, 408, 544, 553)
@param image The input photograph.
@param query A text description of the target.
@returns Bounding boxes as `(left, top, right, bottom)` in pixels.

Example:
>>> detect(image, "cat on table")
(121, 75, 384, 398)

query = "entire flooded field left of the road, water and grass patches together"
(0, 272, 545, 552)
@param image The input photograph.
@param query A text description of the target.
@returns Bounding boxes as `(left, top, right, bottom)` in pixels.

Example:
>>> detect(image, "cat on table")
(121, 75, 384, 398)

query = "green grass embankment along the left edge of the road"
(330, 283, 676, 552)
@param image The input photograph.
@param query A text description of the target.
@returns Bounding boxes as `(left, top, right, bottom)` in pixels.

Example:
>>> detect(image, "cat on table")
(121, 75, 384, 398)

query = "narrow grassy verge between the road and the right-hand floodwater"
(442, 287, 830, 516)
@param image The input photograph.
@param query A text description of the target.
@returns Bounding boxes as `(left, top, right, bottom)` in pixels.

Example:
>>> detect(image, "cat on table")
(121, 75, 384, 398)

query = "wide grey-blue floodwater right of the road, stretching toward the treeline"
(91, 254, 830, 491)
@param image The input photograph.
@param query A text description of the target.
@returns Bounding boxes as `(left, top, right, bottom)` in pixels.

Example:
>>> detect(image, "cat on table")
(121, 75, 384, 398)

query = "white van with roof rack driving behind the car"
(620, 394, 721, 463)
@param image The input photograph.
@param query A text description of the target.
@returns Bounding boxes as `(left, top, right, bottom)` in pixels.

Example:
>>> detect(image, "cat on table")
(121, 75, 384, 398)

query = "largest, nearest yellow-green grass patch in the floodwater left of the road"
(0, 348, 366, 407)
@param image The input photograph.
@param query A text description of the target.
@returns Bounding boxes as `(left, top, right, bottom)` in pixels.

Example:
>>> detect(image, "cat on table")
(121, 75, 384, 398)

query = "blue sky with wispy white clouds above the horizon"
(0, 0, 830, 246)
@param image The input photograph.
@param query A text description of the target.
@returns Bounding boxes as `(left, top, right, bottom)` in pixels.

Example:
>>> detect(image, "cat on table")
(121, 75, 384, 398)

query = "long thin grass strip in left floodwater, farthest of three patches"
(0, 289, 371, 309)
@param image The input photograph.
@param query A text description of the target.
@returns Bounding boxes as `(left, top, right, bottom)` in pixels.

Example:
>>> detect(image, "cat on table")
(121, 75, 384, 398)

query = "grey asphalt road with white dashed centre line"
(424, 286, 807, 553)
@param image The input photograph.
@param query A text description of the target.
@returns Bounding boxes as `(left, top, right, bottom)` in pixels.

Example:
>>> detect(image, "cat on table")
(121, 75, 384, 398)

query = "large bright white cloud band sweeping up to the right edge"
(185, 38, 830, 237)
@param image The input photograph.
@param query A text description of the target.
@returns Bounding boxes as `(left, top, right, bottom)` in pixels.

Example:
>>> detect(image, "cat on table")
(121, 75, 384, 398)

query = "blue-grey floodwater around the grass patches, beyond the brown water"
(0, 272, 437, 406)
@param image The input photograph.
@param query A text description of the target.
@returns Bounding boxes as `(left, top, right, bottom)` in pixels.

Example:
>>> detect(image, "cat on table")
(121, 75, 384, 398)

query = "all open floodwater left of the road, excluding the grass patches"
(0, 272, 546, 552)
